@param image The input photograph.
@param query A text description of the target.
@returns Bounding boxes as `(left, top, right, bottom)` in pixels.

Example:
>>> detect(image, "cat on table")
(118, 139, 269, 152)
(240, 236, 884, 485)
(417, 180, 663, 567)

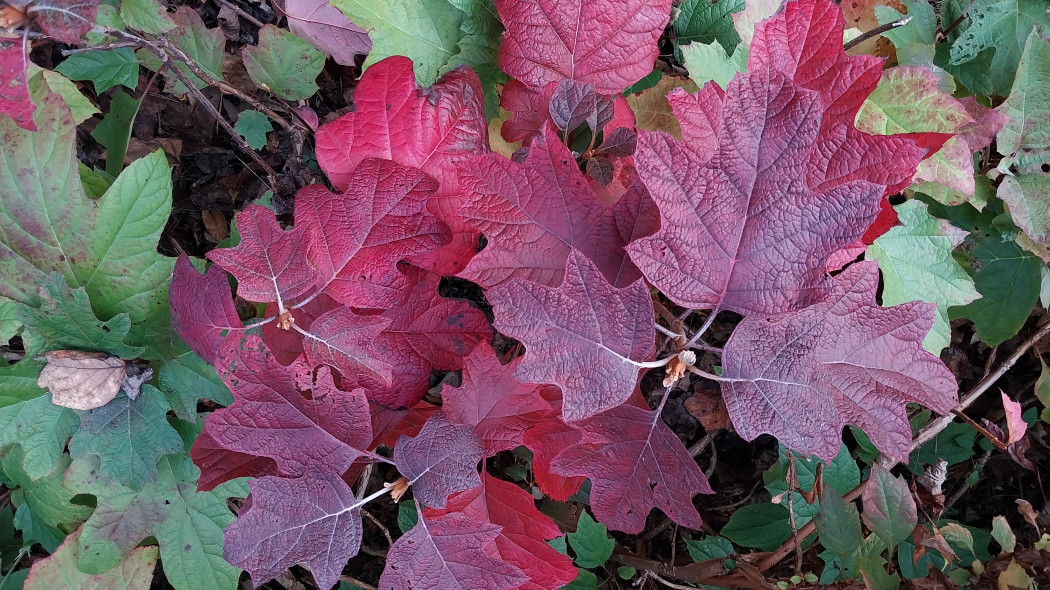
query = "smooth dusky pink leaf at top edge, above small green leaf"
(280, 0, 372, 66)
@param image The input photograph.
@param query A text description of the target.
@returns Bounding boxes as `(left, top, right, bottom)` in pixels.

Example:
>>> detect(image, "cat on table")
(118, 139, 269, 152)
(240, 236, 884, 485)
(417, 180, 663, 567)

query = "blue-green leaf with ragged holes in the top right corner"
(942, 0, 1050, 94)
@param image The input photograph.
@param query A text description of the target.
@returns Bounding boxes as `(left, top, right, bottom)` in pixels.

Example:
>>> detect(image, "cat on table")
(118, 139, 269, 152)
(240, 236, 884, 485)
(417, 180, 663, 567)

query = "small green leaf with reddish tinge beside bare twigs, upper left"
(240, 24, 324, 101)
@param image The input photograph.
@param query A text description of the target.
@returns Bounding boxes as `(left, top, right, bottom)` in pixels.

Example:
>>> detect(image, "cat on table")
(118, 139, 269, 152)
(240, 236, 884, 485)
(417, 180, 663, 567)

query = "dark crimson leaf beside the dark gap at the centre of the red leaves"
(344, 268, 492, 408)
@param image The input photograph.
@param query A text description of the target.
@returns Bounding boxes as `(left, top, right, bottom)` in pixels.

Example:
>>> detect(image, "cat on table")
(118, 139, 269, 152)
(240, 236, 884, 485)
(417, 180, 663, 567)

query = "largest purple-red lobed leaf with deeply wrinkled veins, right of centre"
(627, 68, 884, 315)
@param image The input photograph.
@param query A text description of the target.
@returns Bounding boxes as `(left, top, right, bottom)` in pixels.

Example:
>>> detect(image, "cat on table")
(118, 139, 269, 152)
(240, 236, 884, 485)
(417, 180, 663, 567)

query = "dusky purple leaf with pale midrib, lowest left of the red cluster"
(223, 467, 361, 588)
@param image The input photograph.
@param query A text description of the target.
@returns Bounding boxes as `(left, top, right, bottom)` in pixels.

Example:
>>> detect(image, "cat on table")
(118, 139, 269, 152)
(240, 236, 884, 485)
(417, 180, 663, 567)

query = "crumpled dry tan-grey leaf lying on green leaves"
(37, 351, 153, 410)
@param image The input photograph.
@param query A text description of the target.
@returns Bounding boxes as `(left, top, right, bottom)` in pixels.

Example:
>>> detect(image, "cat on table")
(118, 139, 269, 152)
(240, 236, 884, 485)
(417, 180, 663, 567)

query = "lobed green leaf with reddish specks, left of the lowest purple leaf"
(66, 455, 247, 590)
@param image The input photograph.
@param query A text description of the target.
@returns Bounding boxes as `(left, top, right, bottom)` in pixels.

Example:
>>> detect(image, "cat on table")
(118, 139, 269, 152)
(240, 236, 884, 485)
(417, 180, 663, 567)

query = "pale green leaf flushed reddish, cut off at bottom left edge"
(25, 524, 156, 590)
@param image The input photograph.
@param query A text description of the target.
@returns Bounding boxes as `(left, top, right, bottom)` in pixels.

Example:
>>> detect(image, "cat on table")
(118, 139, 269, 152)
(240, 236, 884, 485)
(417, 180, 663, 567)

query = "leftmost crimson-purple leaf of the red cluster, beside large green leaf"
(168, 255, 245, 365)
